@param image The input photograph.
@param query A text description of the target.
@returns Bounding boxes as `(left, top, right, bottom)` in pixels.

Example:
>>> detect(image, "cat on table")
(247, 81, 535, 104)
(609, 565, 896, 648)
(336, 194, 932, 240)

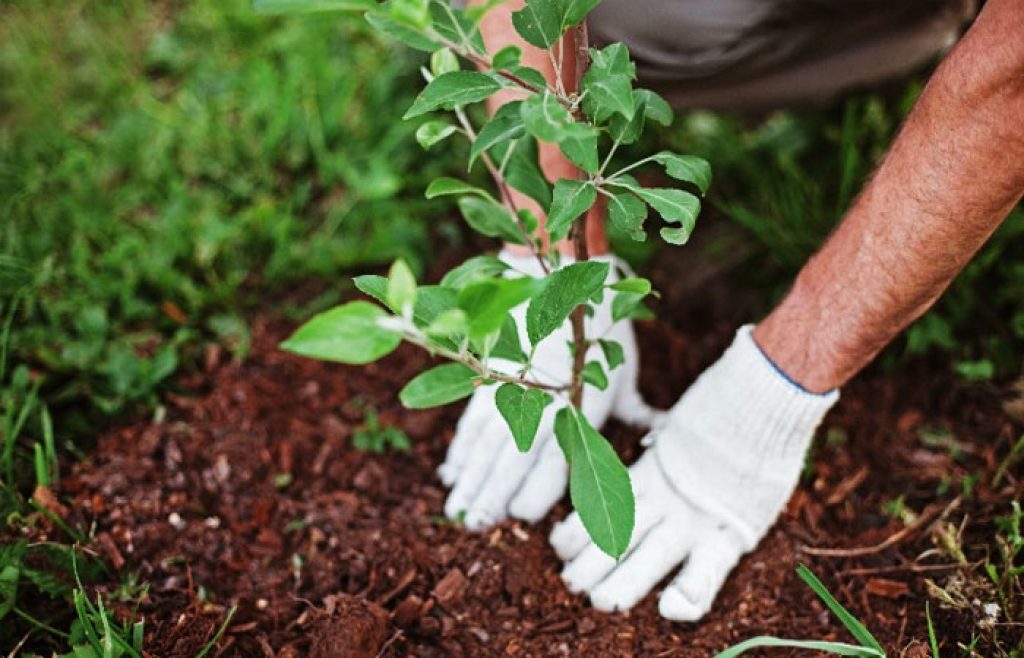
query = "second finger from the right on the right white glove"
(590, 517, 694, 612)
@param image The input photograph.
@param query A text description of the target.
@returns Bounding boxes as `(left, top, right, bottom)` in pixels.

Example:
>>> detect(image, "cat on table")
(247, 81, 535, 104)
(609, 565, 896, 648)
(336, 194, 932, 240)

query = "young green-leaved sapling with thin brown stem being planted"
(255, 0, 711, 558)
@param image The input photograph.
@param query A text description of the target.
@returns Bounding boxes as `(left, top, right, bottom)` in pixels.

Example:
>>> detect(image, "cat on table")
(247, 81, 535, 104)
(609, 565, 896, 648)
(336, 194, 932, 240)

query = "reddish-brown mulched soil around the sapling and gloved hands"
(44, 249, 1024, 658)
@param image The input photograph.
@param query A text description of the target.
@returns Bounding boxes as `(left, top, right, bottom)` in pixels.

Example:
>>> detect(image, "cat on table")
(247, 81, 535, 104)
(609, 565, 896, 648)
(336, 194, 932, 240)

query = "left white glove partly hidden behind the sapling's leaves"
(437, 252, 664, 530)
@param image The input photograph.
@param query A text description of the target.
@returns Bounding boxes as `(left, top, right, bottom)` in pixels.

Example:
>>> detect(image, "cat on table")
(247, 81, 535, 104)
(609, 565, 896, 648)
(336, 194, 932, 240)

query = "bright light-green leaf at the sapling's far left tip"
(281, 301, 401, 365)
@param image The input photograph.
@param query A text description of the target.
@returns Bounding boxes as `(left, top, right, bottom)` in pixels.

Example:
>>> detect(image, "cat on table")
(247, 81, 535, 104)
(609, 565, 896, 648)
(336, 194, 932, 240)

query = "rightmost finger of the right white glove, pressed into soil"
(657, 526, 743, 621)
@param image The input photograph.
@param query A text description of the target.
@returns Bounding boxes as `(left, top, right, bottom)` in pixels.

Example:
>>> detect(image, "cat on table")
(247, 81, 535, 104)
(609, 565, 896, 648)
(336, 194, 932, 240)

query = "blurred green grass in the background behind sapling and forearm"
(0, 0, 1024, 646)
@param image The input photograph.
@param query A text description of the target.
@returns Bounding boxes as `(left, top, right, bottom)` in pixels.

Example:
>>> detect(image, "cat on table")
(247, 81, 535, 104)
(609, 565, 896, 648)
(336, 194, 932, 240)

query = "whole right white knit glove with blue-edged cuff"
(551, 325, 839, 621)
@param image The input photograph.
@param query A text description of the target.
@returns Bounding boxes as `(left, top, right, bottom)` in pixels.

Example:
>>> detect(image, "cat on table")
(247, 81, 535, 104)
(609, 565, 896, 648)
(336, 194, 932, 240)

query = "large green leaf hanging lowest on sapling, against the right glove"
(555, 407, 636, 559)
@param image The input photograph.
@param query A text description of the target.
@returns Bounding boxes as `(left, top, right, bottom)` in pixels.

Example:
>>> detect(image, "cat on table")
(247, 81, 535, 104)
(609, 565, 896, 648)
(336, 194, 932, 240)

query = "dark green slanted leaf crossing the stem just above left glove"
(526, 261, 608, 345)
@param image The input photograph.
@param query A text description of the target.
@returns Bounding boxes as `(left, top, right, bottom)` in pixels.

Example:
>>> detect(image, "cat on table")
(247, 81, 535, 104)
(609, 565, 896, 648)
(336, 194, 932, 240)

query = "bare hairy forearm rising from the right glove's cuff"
(754, 0, 1024, 391)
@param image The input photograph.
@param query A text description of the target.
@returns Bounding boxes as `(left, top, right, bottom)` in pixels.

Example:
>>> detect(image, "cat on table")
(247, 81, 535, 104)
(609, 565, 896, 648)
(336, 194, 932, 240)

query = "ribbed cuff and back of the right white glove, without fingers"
(654, 324, 839, 549)
